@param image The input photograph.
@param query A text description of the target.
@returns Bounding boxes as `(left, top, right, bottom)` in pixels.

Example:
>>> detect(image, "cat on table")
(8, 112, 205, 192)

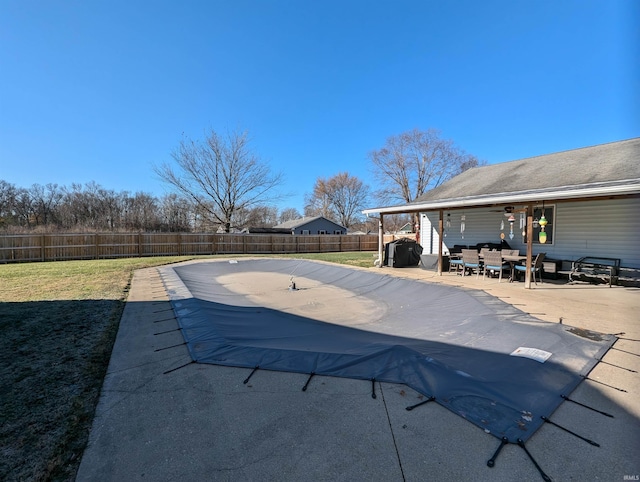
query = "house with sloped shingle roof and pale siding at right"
(363, 138, 640, 278)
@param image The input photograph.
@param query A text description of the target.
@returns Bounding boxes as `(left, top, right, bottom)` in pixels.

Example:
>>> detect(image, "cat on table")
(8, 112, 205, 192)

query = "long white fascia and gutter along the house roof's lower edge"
(362, 179, 640, 215)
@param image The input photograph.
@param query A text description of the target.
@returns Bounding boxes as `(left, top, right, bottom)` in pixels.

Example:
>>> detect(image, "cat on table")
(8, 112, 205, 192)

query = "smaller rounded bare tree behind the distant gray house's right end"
(305, 172, 369, 228)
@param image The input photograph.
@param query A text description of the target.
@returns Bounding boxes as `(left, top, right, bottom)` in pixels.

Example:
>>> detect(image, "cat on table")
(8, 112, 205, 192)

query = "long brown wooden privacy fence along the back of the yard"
(0, 233, 378, 263)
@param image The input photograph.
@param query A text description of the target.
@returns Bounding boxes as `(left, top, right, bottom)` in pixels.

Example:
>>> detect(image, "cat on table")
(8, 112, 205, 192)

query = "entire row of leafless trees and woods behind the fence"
(0, 129, 483, 232)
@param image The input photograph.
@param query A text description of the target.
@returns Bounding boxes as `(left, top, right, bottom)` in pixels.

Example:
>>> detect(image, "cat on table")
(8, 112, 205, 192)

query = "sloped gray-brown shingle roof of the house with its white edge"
(363, 138, 640, 213)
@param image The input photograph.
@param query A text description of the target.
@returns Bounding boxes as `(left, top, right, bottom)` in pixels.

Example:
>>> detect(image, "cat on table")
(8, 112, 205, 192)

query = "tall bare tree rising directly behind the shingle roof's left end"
(369, 129, 483, 203)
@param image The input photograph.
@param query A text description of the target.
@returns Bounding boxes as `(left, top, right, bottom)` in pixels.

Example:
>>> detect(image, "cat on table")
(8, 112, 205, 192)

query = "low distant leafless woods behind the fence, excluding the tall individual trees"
(0, 180, 308, 233)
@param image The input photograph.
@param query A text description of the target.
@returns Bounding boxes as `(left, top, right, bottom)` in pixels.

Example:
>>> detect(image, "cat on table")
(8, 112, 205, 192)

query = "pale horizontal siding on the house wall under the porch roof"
(421, 198, 640, 269)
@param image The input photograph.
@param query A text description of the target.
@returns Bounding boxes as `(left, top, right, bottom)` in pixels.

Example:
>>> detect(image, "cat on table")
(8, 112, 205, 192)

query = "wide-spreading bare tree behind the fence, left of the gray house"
(154, 130, 282, 233)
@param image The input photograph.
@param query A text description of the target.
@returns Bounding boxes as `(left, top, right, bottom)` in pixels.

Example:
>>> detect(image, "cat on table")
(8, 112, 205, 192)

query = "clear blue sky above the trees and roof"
(0, 0, 640, 212)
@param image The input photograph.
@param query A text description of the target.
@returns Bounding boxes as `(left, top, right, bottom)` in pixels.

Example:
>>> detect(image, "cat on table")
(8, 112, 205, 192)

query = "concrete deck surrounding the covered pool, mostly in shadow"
(77, 262, 640, 481)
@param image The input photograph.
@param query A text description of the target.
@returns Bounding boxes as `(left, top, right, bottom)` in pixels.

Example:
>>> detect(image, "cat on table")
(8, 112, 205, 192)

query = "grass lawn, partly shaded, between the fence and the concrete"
(0, 252, 376, 481)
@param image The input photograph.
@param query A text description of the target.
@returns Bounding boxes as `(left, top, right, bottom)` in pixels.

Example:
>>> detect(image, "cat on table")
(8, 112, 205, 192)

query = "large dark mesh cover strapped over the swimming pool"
(160, 259, 616, 443)
